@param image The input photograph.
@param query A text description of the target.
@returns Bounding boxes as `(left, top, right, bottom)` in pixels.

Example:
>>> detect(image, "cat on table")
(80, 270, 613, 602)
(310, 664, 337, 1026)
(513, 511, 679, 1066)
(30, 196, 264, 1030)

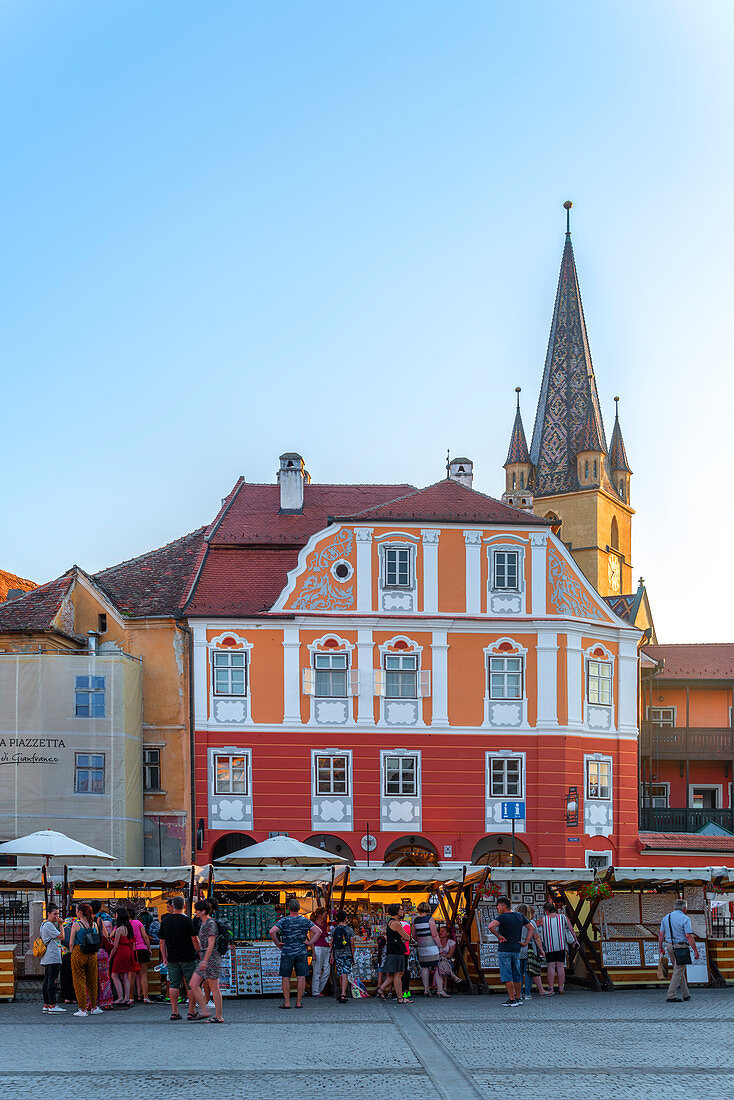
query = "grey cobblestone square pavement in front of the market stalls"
(0, 989, 734, 1100)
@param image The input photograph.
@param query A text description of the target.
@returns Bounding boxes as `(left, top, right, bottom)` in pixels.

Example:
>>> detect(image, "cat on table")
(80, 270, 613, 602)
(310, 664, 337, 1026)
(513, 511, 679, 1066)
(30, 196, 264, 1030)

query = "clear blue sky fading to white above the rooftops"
(0, 0, 734, 641)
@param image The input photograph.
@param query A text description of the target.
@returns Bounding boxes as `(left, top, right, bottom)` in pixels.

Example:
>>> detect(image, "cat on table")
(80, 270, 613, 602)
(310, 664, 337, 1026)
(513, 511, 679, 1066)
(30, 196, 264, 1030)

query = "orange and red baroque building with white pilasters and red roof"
(182, 453, 640, 867)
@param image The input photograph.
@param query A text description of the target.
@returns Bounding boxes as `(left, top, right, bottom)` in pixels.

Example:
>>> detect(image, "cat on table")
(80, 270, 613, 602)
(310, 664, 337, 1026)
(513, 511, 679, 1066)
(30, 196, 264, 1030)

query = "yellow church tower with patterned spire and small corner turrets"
(503, 202, 634, 596)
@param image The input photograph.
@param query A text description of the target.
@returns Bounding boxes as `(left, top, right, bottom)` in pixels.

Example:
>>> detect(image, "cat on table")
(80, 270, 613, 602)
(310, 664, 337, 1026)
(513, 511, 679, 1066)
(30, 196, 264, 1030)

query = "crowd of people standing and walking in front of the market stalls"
(35, 897, 698, 1024)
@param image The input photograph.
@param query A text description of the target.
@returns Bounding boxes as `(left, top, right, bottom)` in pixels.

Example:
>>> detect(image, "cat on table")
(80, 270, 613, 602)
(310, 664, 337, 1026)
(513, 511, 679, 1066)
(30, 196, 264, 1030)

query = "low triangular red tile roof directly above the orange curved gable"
(332, 477, 550, 527)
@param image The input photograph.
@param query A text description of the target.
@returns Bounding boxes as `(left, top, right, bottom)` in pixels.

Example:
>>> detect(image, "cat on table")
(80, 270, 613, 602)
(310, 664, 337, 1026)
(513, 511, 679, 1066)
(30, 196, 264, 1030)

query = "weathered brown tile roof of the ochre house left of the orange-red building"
(92, 527, 206, 618)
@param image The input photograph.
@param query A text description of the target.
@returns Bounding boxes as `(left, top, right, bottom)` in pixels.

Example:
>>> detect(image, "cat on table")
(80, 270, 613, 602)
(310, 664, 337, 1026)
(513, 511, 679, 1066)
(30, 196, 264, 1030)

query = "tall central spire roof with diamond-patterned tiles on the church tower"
(530, 231, 606, 496)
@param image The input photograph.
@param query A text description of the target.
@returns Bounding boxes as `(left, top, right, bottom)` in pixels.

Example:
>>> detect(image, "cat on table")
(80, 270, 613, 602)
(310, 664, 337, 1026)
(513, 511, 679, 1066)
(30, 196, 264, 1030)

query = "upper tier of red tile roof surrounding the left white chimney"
(207, 479, 416, 546)
